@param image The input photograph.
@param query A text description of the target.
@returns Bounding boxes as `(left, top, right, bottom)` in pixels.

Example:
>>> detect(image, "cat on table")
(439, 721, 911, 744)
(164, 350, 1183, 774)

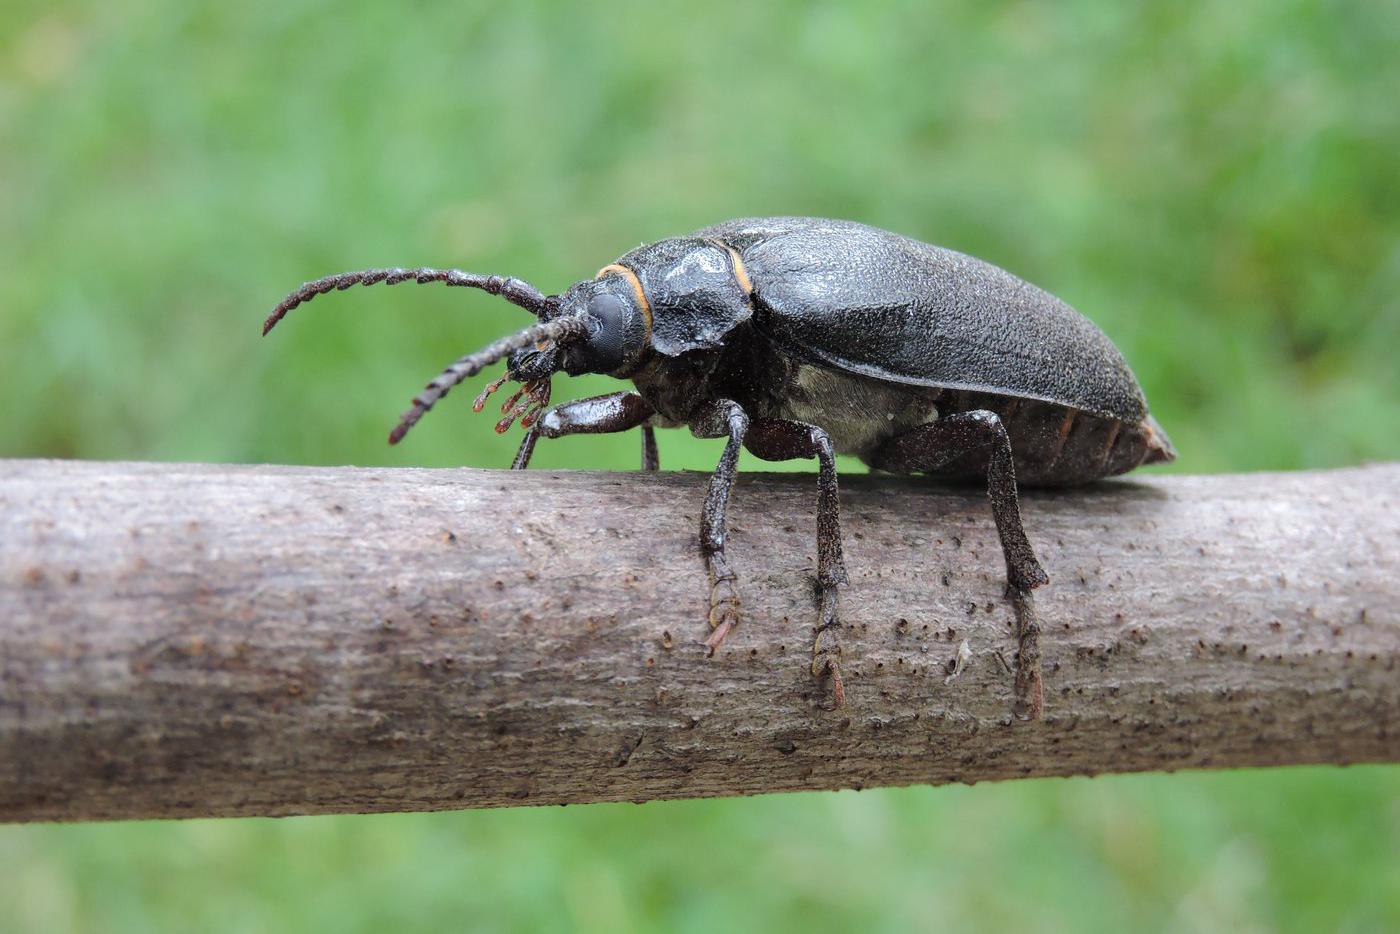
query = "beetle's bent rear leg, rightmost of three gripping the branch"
(871, 409, 1050, 720)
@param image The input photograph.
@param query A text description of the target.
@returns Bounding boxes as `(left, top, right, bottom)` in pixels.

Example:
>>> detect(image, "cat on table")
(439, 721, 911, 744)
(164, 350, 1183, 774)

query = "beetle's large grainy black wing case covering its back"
(696, 217, 1147, 424)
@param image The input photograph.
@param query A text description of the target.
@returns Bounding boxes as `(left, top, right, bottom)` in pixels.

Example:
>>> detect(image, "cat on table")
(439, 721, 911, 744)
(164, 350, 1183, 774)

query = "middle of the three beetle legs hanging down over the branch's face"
(745, 419, 847, 710)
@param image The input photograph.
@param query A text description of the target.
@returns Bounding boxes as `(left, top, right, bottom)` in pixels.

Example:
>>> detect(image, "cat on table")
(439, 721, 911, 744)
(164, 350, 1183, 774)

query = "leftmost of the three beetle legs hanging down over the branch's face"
(690, 399, 749, 655)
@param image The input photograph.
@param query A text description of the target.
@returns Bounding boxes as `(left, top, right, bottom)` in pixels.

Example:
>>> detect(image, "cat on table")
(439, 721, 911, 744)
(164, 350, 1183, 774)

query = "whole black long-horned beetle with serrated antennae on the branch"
(263, 217, 1176, 710)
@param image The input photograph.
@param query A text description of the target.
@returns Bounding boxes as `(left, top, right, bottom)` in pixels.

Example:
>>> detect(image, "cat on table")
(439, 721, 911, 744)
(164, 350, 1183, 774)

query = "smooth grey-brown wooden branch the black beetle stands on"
(0, 461, 1400, 821)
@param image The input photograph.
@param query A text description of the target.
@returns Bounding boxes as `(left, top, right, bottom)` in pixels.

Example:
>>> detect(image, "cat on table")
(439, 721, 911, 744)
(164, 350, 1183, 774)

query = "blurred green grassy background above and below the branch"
(0, 0, 1400, 931)
